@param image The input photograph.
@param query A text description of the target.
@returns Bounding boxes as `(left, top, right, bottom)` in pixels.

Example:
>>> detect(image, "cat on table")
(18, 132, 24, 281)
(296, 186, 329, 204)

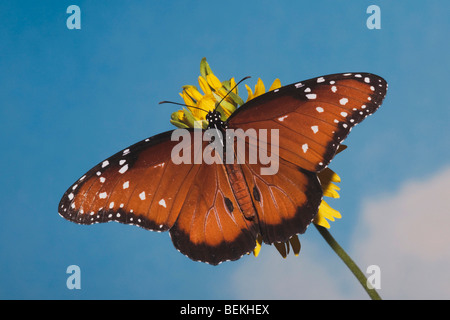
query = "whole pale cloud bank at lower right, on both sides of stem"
(231, 168, 450, 299)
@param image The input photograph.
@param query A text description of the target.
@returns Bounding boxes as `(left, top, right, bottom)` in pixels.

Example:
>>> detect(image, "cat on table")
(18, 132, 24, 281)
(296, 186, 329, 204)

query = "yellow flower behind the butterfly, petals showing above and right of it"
(170, 58, 346, 258)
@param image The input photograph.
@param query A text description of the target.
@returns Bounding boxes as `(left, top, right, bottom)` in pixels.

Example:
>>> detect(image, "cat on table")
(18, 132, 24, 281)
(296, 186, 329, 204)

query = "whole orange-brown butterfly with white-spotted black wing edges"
(58, 73, 387, 265)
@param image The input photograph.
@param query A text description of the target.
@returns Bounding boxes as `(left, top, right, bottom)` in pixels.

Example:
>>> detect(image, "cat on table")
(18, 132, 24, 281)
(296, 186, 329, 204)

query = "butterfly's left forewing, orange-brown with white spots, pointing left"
(59, 132, 198, 231)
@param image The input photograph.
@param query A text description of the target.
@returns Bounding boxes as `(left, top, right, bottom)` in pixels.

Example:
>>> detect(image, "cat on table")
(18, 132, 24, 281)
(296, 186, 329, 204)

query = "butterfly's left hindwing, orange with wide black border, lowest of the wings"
(170, 148, 258, 265)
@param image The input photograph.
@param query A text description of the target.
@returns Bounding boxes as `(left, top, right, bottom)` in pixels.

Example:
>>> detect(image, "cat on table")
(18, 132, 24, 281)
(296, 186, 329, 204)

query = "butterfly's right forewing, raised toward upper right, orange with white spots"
(228, 73, 387, 172)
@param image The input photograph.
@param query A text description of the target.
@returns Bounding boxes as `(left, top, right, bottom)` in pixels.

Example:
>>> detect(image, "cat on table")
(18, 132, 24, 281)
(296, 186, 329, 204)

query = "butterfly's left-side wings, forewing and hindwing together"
(58, 131, 257, 264)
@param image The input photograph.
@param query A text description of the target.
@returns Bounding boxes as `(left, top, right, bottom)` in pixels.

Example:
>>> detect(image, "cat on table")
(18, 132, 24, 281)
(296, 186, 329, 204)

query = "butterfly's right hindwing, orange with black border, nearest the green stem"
(242, 159, 322, 244)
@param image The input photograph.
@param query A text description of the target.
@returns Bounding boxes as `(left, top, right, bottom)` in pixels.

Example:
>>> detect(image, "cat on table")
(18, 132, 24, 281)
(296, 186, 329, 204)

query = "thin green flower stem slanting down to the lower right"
(314, 224, 381, 300)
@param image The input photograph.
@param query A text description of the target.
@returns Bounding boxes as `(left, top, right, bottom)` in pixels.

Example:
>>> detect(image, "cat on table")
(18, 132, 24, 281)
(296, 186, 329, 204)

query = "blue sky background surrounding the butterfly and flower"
(0, 0, 450, 299)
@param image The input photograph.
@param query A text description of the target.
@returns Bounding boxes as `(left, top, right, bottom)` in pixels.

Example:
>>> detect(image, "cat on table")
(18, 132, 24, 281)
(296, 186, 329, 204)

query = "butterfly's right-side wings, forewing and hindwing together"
(228, 73, 387, 243)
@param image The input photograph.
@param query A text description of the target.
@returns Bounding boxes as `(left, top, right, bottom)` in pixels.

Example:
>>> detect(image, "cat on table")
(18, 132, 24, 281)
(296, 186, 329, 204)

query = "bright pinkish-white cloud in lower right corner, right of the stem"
(353, 168, 450, 299)
